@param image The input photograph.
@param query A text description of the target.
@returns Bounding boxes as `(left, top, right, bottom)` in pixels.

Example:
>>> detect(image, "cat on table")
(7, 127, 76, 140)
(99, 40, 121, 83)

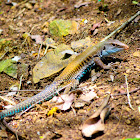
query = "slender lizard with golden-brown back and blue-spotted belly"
(0, 40, 129, 120)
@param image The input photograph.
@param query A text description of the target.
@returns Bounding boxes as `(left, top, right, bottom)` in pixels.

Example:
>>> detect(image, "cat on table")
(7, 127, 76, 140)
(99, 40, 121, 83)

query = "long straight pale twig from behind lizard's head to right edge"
(101, 11, 140, 42)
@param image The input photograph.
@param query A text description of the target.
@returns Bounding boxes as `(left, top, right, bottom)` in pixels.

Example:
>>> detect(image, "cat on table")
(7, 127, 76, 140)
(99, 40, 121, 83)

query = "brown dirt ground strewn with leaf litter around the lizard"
(0, 0, 140, 140)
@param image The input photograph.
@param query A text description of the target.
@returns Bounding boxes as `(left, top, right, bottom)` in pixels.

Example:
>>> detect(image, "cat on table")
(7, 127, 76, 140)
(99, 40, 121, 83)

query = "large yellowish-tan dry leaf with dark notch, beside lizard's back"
(33, 44, 76, 83)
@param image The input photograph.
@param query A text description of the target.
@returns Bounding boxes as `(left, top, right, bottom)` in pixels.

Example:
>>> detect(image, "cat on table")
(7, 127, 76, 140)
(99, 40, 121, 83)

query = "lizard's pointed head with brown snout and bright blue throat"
(102, 39, 129, 56)
